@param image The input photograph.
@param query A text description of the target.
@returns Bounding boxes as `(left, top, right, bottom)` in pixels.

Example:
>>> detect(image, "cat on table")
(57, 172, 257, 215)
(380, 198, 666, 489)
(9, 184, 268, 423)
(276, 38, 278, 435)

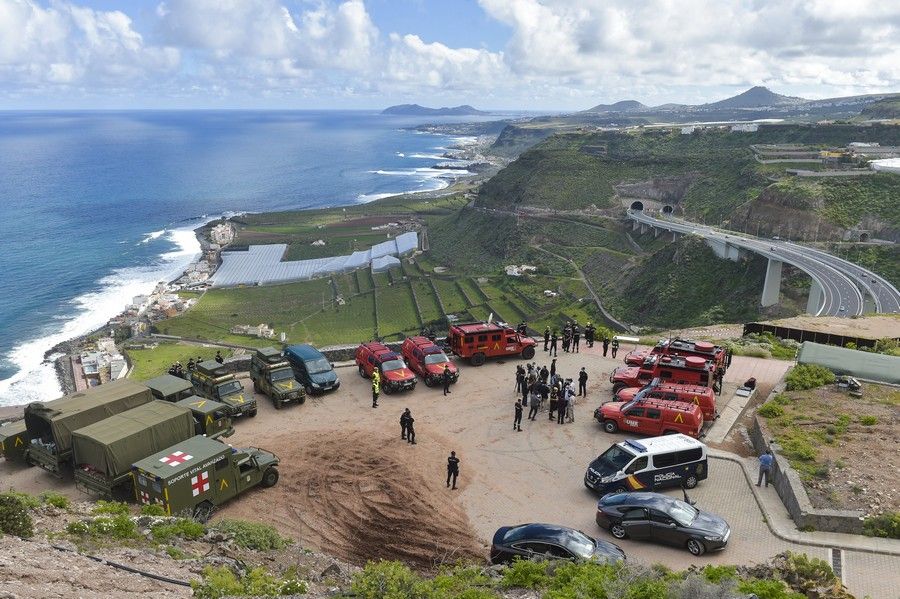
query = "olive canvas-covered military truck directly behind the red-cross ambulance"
(72, 400, 194, 496)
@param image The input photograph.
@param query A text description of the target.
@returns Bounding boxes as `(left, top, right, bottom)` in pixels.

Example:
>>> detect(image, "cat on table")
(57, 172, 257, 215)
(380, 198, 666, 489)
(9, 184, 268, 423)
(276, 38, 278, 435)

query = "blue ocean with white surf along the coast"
(0, 111, 498, 405)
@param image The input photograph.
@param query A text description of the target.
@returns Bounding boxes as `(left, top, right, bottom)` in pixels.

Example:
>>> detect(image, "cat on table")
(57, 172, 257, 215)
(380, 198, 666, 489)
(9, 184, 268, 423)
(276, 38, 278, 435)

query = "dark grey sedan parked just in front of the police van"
(597, 493, 731, 555)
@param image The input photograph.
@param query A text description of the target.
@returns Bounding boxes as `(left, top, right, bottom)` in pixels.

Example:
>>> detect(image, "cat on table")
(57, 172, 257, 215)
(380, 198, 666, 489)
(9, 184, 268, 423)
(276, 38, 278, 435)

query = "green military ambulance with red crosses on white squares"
(132, 436, 279, 521)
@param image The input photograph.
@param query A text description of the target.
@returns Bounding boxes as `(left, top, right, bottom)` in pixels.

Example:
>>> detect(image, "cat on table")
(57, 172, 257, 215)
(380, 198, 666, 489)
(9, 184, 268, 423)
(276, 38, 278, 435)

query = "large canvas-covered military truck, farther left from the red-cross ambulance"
(25, 379, 153, 476)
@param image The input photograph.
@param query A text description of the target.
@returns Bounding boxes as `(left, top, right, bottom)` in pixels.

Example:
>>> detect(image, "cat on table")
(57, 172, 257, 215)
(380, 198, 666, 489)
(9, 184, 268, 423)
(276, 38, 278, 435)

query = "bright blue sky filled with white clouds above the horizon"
(0, 0, 900, 111)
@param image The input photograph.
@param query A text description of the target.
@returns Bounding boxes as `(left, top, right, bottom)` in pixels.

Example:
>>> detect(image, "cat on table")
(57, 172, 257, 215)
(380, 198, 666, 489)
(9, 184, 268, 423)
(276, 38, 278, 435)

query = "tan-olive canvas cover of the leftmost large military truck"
(25, 379, 153, 453)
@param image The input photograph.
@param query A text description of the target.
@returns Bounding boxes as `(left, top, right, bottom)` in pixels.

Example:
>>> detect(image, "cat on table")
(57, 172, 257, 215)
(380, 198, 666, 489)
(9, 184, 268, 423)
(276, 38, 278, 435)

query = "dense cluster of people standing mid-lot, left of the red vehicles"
(513, 358, 588, 432)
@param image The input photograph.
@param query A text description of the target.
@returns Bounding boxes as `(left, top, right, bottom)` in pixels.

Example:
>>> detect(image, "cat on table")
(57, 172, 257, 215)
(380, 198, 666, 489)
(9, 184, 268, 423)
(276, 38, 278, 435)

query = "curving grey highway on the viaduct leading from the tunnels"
(628, 210, 900, 317)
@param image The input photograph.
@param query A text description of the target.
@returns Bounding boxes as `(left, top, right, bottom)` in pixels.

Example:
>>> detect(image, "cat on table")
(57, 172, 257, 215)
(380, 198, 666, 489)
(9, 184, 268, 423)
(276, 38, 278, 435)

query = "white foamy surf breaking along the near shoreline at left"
(0, 228, 200, 405)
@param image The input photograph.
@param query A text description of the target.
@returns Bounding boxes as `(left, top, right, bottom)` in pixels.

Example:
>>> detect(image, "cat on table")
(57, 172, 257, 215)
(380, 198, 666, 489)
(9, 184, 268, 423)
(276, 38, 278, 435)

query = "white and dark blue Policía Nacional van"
(584, 434, 709, 495)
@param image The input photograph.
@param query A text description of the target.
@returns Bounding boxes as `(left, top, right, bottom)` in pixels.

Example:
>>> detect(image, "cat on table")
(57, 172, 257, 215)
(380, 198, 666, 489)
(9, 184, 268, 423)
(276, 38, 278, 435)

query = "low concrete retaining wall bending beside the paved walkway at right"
(750, 416, 863, 534)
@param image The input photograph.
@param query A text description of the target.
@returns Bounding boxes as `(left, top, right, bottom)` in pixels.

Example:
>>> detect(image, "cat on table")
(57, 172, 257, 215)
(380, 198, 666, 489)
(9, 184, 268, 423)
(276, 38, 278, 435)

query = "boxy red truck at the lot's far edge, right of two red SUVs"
(447, 322, 535, 366)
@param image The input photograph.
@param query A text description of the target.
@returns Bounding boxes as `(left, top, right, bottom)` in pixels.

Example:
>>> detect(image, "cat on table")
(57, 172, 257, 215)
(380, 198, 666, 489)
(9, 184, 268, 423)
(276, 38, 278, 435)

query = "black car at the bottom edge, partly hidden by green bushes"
(491, 524, 625, 564)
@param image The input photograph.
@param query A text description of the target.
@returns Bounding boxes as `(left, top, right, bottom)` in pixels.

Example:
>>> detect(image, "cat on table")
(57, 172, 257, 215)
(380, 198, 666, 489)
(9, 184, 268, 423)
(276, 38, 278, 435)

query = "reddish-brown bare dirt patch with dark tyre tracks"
(222, 427, 485, 569)
